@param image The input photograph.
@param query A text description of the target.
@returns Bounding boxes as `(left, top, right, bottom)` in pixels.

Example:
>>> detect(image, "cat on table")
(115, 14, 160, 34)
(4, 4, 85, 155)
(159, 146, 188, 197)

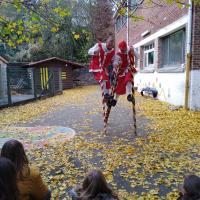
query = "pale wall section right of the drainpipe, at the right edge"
(189, 70, 200, 110)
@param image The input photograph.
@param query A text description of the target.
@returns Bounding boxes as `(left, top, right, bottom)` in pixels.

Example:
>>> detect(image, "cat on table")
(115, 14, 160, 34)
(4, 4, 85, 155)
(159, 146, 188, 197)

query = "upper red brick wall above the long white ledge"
(115, 0, 188, 45)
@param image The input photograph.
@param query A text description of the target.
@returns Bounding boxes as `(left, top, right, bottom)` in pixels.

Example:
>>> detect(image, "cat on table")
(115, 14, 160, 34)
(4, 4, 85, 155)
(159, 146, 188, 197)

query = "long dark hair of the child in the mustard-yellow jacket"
(1, 140, 30, 180)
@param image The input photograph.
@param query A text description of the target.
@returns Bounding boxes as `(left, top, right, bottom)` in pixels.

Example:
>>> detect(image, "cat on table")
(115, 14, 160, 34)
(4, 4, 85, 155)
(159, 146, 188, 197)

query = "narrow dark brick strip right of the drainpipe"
(192, 6, 200, 69)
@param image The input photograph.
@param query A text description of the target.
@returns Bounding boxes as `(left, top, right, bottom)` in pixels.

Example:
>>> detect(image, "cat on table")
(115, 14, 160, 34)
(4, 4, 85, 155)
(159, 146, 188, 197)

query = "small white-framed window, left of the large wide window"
(144, 43, 154, 68)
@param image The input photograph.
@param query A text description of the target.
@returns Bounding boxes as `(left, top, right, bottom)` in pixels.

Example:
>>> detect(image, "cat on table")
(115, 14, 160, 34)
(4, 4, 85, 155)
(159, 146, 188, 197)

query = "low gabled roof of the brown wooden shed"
(24, 57, 85, 68)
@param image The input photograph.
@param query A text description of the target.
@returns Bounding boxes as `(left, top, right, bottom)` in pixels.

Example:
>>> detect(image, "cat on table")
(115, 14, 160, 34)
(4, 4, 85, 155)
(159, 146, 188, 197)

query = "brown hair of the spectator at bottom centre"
(75, 170, 118, 200)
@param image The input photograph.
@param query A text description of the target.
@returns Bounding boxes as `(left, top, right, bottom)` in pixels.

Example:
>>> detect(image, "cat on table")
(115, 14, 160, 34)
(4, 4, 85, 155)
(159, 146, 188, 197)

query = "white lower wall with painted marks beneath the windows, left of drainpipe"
(134, 72, 186, 106)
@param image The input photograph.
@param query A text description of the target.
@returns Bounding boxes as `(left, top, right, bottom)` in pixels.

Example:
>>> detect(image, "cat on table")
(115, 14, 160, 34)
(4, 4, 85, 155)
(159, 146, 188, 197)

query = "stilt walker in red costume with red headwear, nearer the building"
(105, 41, 136, 135)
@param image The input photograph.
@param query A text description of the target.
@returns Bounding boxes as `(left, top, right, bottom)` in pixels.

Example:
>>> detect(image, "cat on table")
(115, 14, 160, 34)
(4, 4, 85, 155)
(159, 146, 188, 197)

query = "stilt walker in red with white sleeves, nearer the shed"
(88, 36, 115, 130)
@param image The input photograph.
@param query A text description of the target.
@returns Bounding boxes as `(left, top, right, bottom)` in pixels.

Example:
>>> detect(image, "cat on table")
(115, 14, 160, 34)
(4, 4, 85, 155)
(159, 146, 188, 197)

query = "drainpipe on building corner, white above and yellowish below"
(184, 0, 192, 110)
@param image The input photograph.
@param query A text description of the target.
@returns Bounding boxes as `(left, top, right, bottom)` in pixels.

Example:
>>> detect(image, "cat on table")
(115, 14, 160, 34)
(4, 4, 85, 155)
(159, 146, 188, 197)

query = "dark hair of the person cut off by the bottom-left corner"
(0, 157, 18, 200)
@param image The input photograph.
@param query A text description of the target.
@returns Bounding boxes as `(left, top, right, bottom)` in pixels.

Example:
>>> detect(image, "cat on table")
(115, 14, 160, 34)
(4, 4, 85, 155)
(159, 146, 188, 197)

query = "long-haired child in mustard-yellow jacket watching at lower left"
(1, 140, 50, 200)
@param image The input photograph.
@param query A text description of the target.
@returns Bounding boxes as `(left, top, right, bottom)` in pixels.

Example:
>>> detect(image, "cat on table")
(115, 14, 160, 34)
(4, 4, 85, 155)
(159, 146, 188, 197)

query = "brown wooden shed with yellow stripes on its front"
(24, 57, 84, 97)
